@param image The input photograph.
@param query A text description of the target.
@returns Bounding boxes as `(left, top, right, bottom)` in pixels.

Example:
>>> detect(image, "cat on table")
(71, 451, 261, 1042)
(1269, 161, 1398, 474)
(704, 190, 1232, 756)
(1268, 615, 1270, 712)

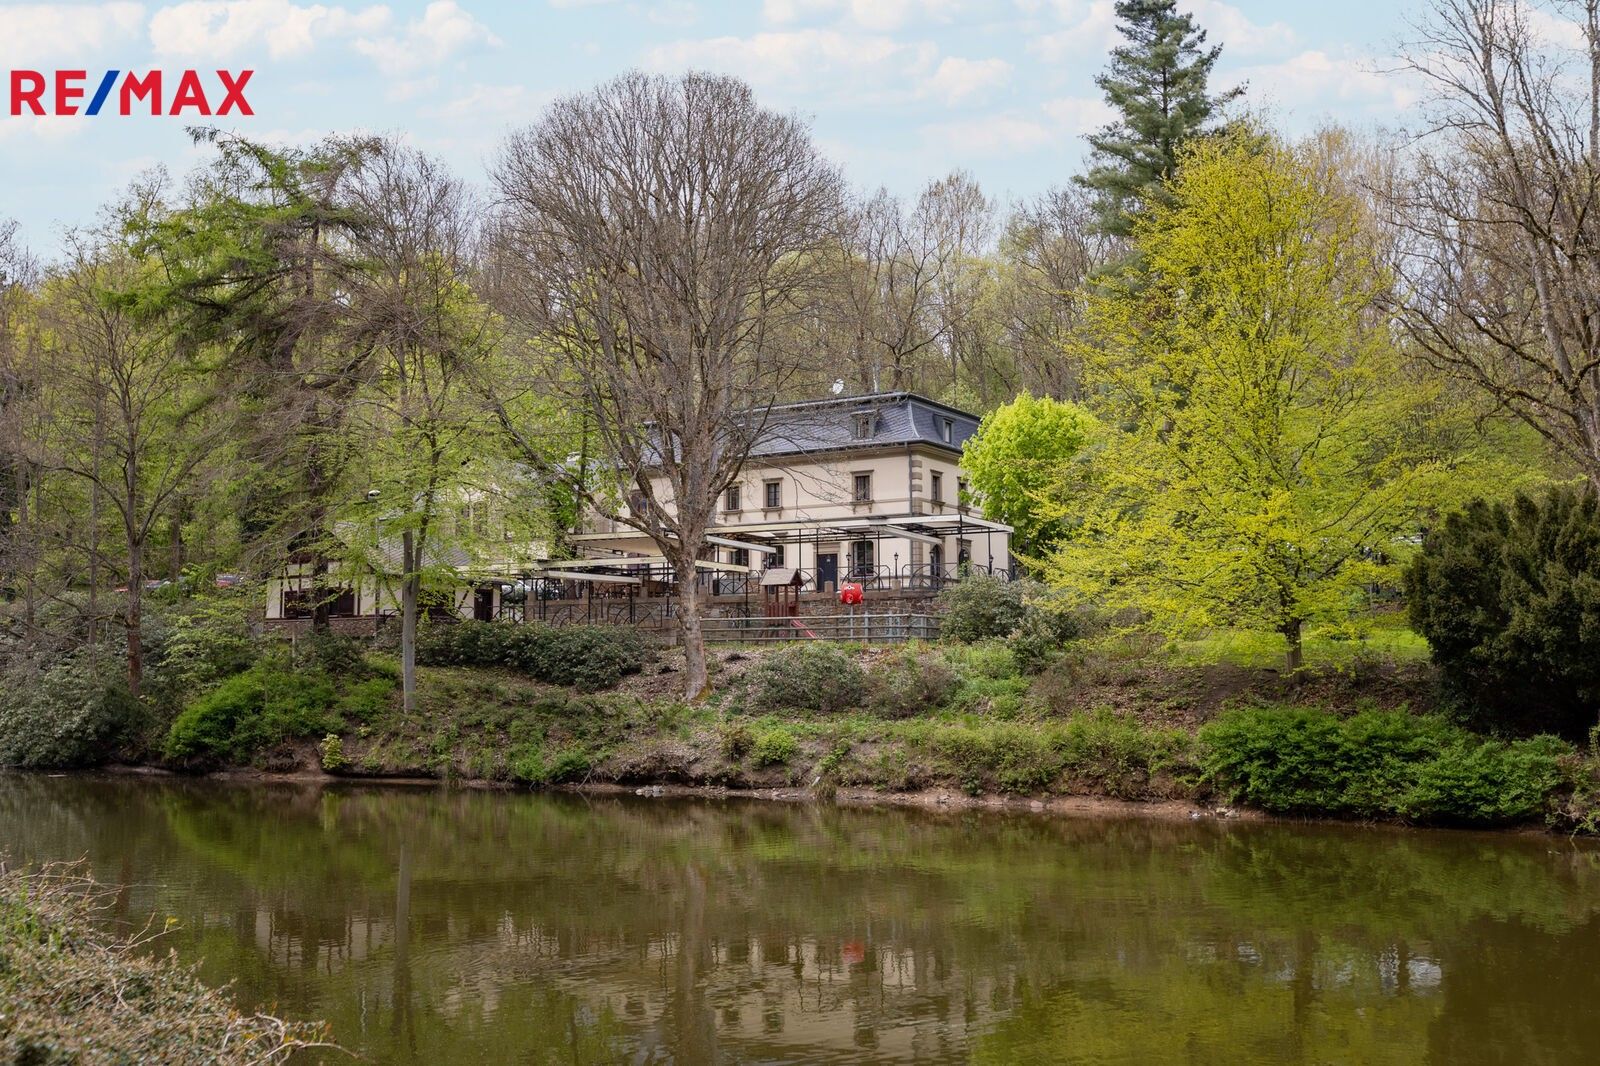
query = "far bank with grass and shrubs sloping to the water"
(131, 633, 1600, 832)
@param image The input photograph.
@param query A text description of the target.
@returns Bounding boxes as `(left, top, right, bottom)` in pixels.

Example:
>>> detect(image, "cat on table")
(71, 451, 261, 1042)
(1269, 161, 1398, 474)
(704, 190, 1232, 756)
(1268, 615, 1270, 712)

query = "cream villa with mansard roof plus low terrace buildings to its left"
(267, 392, 1011, 629)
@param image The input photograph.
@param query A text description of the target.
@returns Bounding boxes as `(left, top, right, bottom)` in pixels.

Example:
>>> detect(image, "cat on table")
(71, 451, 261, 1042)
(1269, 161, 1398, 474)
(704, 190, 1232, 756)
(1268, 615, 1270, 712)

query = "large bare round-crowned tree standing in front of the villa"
(494, 72, 842, 698)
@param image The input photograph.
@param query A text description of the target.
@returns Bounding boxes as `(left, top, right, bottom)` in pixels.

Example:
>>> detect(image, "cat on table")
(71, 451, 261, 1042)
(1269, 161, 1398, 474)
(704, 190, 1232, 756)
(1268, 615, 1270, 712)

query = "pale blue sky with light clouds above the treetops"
(0, 0, 1422, 254)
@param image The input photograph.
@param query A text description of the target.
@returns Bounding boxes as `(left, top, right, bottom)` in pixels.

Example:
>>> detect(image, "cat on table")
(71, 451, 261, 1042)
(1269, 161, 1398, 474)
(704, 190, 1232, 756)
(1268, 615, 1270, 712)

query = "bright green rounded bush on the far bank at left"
(165, 659, 342, 762)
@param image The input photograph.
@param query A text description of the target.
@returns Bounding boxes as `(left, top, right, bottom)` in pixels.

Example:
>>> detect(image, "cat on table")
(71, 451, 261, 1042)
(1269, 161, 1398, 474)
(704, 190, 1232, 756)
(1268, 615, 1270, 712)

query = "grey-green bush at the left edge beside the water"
(0, 653, 146, 768)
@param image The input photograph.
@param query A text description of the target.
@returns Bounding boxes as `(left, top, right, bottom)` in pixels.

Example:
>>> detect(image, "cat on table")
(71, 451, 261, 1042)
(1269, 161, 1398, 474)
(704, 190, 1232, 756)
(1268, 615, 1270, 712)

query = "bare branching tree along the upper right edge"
(1394, 0, 1600, 487)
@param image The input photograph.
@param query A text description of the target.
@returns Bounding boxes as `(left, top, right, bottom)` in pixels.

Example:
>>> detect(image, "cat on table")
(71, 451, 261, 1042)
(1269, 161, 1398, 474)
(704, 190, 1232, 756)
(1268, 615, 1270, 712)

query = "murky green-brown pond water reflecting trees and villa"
(0, 776, 1600, 1064)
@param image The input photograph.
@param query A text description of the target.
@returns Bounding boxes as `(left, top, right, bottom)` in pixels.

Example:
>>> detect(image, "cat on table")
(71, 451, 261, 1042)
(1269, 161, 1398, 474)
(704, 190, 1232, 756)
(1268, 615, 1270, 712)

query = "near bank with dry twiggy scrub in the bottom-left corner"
(0, 863, 331, 1064)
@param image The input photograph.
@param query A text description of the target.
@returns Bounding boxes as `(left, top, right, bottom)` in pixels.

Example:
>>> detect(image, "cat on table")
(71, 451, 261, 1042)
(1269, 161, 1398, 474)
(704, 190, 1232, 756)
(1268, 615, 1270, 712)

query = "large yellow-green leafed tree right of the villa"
(1046, 131, 1529, 669)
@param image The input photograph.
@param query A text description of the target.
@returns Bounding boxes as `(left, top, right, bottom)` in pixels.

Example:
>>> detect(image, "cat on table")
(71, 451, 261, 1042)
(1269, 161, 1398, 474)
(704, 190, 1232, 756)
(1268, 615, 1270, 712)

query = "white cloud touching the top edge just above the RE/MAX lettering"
(150, 0, 389, 59)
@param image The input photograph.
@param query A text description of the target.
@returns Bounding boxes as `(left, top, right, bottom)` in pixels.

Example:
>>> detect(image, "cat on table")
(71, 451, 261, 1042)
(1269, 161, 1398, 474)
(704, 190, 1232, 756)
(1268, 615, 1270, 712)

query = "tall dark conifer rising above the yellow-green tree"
(1077, 0, 1245, 237)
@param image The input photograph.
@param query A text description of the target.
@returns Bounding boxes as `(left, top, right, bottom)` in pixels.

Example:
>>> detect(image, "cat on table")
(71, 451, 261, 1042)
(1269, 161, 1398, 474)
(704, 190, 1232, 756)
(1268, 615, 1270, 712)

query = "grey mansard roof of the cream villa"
(750, 392, 978, 458)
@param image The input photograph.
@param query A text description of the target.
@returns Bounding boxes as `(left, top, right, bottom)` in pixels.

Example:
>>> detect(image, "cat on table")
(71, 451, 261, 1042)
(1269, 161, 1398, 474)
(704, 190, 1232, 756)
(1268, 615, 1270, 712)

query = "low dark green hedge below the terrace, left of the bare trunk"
(416, 621, 650, 691)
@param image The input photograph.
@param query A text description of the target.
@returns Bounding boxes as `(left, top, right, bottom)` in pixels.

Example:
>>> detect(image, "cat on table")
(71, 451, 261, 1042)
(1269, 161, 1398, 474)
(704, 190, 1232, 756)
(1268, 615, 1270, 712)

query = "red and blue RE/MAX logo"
(11, 70, 256, 115)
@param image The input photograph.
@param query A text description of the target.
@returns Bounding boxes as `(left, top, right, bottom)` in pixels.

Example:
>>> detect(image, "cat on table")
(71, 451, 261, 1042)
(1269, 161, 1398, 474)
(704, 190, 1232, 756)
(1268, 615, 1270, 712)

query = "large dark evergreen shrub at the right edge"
(1406, 490, 1600, 739)
